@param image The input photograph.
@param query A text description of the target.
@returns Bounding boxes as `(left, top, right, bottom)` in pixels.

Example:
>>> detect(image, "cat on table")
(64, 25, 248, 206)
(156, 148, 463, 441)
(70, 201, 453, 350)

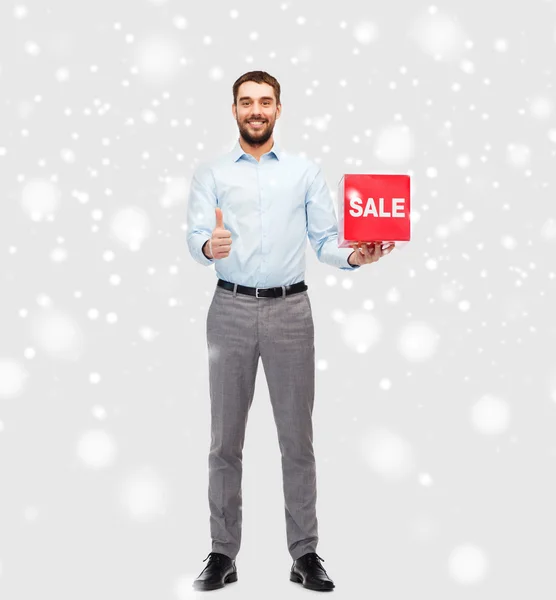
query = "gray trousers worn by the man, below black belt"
(207, 286, 318, 560)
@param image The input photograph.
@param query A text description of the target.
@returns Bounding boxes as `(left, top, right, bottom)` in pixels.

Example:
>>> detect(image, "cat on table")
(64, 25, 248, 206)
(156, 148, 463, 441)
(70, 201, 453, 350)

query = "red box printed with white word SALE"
(338, 174, 411, 248)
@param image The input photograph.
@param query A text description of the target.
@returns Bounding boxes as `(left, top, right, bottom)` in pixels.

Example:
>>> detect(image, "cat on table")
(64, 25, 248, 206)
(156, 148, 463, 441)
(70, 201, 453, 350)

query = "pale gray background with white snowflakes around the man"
(0, 0, 556, 600)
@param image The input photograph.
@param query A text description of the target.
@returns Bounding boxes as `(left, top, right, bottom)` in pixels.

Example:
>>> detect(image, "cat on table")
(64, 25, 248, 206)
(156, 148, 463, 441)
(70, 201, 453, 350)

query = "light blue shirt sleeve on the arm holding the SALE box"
(305, 167, 360, 271)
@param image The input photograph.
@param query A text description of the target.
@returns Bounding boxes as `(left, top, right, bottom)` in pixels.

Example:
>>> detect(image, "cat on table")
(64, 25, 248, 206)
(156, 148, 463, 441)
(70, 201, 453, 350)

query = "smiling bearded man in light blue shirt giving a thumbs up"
(187, 71, 394, 591)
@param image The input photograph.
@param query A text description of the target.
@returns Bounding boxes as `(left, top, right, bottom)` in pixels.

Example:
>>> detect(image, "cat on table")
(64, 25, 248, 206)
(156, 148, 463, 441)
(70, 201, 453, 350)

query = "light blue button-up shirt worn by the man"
(187, 139, 359, 288)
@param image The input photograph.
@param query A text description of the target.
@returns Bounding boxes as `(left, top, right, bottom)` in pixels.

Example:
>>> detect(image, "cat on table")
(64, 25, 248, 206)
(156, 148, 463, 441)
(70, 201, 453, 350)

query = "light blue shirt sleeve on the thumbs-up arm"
(187, 164, 216, 266)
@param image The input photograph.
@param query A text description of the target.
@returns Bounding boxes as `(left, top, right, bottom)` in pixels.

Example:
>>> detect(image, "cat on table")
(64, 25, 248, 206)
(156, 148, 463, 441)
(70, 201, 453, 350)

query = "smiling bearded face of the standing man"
(232, 81, 282, 146)
